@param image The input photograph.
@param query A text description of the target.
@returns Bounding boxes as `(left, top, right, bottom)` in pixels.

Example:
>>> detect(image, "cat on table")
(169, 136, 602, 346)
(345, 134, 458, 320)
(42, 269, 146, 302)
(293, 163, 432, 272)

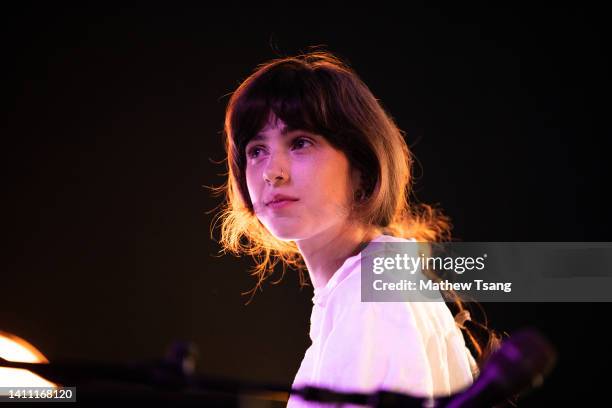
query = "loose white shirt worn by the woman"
(287, 235, 477, 408)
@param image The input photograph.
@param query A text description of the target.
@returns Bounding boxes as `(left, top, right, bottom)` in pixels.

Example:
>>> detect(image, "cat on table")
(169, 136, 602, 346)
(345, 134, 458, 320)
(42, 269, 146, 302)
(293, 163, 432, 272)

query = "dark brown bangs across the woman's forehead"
(231, 63, 330, 154)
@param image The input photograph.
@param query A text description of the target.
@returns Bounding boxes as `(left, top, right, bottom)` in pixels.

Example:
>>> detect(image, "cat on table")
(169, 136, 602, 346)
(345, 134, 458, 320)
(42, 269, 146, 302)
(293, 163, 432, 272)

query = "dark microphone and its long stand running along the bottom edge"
(0, 331, 556, 408)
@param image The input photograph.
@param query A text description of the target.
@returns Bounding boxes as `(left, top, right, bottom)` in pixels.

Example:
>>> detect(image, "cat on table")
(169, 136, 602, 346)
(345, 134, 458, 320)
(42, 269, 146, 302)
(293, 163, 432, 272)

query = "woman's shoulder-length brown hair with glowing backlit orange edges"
(212, 51, 499, 372)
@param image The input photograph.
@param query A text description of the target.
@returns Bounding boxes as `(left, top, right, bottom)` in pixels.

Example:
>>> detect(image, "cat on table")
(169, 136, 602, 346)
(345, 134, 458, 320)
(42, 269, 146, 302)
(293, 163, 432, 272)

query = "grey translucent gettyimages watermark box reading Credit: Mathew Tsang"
(361, 242, 612, 302)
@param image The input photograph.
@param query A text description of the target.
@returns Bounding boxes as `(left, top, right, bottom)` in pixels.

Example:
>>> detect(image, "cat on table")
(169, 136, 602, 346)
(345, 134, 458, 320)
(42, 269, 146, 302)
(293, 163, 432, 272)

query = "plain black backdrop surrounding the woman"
(0, 5, 611, 406)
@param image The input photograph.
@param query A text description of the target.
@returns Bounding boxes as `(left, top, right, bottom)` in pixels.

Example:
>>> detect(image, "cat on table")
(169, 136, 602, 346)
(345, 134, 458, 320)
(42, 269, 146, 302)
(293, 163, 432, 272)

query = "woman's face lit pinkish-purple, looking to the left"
(246, 115, 359, 241)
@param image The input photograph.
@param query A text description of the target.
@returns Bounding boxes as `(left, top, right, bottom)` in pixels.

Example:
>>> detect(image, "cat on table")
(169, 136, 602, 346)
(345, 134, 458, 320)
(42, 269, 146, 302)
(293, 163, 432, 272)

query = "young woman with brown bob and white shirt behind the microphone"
(217, 51, 500, 407)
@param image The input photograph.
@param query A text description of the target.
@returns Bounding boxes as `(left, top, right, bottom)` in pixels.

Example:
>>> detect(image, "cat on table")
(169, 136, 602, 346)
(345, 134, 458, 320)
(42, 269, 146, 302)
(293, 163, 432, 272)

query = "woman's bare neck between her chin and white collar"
(296, 225, 382, 289)
